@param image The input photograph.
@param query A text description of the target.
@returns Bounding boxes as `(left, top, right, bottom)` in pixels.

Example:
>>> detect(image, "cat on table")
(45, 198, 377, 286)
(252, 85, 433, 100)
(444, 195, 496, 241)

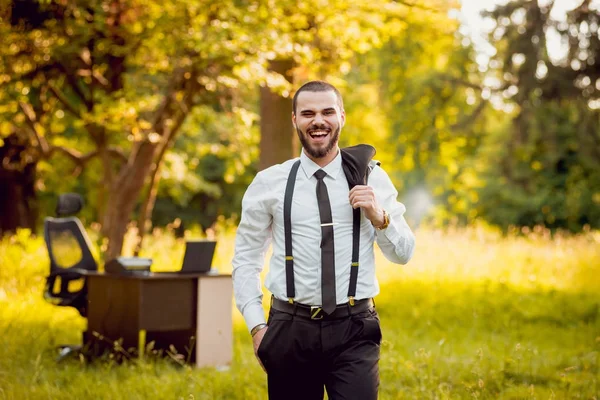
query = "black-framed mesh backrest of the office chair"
(44, 217, 98, 273)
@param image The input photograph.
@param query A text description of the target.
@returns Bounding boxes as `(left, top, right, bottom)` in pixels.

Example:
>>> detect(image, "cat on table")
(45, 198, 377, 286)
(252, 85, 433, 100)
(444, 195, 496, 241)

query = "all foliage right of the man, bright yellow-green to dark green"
(346, 1, 600, 231)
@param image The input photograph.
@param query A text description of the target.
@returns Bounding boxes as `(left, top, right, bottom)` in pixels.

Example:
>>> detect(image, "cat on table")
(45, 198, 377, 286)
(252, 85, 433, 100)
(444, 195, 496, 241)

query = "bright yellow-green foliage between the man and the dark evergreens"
(338, 3, 487, 224)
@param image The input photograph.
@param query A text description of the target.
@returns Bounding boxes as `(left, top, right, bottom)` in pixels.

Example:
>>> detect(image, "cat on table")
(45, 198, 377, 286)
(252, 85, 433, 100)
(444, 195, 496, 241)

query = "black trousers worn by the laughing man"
(257, 309, 381, 400)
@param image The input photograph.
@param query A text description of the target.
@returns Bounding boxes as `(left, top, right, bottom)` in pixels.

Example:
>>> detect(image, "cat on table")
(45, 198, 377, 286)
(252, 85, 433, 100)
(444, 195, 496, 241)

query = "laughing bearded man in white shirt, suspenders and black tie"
(233, 81, 415, 400)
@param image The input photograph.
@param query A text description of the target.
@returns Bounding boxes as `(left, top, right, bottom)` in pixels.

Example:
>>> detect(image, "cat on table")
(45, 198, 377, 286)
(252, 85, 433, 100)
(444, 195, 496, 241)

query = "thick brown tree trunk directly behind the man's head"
(259, 60, 299, 170)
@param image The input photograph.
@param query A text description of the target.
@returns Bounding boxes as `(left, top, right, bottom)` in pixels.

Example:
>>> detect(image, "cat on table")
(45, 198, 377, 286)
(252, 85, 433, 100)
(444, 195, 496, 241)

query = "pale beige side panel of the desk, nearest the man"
(196, 276, 233, 367)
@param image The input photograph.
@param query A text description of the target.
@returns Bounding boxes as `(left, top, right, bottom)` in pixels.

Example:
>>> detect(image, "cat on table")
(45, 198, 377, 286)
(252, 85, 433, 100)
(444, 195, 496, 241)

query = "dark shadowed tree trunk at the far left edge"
(0, 135, 38, 236)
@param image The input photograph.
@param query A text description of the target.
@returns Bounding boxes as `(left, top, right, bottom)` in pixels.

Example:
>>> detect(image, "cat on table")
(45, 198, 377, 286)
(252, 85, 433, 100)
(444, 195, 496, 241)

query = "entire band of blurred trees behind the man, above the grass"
(0, 0, 600, 255)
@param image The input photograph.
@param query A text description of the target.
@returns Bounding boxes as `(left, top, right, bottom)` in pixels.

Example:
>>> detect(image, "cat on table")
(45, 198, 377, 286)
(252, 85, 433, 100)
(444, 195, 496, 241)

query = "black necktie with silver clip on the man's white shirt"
(315, 169, 337, 314)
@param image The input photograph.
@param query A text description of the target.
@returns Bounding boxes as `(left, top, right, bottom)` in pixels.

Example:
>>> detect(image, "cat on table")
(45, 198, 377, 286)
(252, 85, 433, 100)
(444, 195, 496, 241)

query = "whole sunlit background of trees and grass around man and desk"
(0, 0, 600, 400)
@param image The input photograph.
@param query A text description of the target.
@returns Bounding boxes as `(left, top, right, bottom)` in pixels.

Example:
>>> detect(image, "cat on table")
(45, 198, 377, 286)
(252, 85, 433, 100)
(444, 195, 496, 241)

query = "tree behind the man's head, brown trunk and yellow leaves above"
(254, 0, 440, 169)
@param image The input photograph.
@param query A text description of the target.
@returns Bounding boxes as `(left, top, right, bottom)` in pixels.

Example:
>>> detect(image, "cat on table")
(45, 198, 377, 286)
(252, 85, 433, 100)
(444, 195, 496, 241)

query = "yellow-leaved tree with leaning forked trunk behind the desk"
(0, 0, 288, 258)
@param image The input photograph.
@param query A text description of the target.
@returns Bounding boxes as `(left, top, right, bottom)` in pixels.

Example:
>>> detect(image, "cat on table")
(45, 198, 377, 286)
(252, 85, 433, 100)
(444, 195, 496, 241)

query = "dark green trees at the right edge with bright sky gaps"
(479, 0, 600, 231)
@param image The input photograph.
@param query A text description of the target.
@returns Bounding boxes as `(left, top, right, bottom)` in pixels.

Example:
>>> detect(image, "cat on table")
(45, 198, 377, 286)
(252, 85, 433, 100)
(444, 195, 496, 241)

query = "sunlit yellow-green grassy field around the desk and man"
(0, 228, 600, 400)
